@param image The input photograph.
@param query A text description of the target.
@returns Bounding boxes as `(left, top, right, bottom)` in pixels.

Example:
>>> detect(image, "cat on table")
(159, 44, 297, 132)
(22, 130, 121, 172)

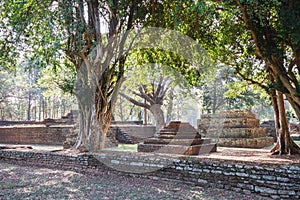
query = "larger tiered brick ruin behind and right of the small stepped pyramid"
(198, 110, 274, 148)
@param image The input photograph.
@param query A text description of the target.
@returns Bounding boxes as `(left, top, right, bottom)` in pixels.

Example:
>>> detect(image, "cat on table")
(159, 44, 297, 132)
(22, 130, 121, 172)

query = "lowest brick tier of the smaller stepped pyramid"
(138, 144, 217, 155)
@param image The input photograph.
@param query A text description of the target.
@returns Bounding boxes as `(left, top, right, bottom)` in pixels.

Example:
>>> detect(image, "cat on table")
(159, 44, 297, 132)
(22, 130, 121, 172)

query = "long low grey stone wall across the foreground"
(0, 150, 300, 199)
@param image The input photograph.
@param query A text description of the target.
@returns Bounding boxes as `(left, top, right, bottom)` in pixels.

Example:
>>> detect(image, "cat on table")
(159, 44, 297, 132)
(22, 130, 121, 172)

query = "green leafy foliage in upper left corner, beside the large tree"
(0, 0, 64, 67)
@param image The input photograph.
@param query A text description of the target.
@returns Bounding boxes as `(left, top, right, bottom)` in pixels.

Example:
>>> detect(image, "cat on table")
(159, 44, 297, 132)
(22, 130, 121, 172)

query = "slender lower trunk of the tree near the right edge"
(271, 91, 300, 155)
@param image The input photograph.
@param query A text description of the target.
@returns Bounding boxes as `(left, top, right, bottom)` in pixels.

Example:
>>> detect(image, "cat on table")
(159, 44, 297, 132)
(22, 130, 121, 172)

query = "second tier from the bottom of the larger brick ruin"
(201, 128, 267, 138)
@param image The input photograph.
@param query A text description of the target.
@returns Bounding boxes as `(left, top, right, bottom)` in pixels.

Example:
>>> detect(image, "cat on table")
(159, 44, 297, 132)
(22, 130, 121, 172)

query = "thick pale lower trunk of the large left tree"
(74, 60, 122, 152)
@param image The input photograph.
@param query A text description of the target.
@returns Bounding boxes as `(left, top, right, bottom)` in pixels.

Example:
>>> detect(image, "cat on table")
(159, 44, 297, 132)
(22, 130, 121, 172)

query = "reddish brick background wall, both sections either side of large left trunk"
(0, 122, 155, 148)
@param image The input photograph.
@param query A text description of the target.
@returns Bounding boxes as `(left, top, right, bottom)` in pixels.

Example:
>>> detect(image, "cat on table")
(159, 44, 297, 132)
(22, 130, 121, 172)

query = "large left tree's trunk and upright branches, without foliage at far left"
(62, 0, 152, 151)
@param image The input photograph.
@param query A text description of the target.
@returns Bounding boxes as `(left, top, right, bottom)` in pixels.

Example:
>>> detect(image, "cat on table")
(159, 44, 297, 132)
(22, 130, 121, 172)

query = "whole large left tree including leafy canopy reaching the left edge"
(0, 0, 150, 151)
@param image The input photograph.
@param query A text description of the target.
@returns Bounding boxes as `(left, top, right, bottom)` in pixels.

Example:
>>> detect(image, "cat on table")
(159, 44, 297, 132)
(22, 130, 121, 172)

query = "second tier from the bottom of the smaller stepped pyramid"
(144, 138, 211, 146)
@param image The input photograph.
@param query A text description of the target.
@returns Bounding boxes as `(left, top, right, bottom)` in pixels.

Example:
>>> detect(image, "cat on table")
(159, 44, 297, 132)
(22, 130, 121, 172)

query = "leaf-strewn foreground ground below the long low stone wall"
(0, 162, 266, 200)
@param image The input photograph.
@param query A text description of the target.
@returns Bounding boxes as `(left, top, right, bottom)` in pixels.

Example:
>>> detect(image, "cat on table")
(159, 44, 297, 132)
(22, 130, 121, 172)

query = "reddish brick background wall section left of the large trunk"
(0, 125, 73, 145)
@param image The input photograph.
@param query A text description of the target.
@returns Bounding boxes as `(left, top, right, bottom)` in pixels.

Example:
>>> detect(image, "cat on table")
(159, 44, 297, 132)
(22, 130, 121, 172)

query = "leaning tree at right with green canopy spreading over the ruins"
(161, 0, 300, 154)
